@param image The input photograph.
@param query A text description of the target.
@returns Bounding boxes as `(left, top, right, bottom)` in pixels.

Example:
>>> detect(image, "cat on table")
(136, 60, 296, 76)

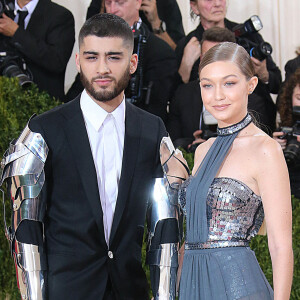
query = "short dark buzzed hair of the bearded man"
(78, 14, 134, 52)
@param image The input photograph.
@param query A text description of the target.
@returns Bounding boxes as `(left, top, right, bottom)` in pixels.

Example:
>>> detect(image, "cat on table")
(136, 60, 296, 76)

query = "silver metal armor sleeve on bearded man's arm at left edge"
(0, 124, 48, 300)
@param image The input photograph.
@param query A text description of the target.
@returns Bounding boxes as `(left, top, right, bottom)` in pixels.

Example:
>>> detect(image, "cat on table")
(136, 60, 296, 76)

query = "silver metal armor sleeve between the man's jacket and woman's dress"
(147, 137, 188, 300)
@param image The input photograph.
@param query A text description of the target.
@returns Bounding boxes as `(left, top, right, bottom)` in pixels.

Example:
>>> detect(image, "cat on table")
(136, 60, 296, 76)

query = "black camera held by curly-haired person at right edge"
(278, 106, 300, 167)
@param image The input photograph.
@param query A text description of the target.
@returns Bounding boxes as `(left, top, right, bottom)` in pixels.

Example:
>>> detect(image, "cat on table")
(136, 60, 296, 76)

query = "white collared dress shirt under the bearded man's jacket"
(80, 90, 125, 244)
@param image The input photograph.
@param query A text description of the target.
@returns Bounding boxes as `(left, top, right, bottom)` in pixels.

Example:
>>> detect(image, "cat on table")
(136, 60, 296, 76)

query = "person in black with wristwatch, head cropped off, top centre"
(87, 0, 185, 49)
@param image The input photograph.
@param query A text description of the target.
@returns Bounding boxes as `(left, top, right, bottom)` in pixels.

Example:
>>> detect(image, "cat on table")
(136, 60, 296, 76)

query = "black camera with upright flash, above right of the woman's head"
(232, 15, 273, 61)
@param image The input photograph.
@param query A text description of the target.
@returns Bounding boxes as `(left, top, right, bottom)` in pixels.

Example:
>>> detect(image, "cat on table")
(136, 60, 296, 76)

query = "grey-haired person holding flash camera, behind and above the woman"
(175, 0, 281, 134)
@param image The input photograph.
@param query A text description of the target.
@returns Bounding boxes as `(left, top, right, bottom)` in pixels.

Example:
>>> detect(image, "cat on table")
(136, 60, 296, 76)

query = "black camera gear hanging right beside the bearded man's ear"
(125, 24, 153, 106)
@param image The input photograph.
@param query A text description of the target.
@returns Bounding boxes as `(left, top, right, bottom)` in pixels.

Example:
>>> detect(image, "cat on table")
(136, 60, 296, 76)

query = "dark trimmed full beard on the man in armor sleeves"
(80, 64, 130, 102)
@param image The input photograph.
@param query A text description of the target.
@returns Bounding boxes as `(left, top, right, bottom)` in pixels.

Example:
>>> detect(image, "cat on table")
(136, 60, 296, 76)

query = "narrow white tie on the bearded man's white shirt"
(101, 114, 118, 244)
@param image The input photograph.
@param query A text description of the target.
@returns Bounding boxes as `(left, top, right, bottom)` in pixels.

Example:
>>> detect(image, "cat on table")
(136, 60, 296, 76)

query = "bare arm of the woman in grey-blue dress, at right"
(256, 138, 293, 300)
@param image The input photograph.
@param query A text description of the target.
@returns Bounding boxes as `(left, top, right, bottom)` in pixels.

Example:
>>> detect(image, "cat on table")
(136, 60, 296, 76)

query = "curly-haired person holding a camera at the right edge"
(273, 68, 300, 198)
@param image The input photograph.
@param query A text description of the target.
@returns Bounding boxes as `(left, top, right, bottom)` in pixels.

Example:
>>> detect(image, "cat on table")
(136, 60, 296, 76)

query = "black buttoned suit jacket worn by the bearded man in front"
(27, 97, 166, 300)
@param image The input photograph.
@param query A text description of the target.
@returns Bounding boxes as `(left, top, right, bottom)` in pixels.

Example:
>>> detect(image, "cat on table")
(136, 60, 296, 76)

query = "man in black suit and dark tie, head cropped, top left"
(0, 0, 75, 101)
